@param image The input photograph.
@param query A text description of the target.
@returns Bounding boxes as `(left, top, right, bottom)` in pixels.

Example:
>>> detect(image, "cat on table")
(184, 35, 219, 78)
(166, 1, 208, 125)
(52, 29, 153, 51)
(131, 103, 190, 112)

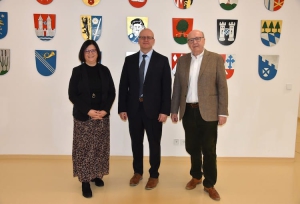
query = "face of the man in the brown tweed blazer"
(188, 30, 205, 56)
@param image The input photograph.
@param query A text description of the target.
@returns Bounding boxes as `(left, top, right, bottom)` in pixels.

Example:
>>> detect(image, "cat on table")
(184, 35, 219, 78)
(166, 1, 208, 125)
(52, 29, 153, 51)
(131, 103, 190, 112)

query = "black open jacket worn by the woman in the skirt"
(68, 63, 116, 121)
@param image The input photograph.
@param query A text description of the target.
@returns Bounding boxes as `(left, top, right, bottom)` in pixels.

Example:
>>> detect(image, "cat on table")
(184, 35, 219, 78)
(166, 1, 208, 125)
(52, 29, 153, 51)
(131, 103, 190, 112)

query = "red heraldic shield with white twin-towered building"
(33, 14, 56, 41)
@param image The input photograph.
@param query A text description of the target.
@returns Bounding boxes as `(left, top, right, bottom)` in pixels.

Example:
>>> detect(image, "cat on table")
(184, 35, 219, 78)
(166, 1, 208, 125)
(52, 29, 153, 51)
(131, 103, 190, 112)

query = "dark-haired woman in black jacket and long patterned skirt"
(69, 40, 116, 198)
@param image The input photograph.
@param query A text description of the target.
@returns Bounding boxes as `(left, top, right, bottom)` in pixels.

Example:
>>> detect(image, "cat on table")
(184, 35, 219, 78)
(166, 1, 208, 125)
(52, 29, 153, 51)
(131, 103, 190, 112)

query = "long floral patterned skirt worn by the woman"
(72, 118, 110, 182)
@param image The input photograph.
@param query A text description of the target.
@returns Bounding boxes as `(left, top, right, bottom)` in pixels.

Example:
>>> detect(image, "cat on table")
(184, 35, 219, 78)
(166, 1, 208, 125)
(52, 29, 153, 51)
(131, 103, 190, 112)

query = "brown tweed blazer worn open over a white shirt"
(171, 50, 228, 121)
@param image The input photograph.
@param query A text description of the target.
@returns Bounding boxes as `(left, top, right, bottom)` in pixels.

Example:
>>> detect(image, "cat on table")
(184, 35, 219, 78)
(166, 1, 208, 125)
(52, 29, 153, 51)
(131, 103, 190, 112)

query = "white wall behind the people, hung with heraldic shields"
(0, 0, 300, 158)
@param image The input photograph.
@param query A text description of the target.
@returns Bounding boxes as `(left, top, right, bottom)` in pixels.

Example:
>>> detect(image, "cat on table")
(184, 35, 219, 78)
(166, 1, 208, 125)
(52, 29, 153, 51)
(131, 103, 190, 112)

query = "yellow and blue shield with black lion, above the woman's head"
(80, 15, 102, 41)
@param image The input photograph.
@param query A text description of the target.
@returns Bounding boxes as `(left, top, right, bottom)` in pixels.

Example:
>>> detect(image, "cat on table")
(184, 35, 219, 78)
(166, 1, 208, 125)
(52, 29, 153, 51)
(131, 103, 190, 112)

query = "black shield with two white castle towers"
(217, 19, 238, 45)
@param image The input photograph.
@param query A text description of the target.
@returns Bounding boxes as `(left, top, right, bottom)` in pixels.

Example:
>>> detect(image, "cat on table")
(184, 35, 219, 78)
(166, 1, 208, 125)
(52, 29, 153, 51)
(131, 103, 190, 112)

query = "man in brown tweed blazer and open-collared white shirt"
(171, 30, 228, 200)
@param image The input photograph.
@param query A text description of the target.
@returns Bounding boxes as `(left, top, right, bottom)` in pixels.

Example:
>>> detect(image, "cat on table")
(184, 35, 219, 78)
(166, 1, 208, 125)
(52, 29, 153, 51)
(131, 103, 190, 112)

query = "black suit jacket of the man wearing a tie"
(118, 50, 172, 119)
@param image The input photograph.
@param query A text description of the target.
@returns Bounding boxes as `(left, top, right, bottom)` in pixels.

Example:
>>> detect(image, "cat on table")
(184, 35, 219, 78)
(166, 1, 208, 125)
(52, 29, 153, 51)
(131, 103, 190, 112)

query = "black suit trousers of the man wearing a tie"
(128, 102, 162, 178)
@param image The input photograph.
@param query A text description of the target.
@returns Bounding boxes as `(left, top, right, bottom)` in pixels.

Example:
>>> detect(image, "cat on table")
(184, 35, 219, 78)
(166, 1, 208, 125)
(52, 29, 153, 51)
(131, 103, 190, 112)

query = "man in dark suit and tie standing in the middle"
(118, 29, 171, 190)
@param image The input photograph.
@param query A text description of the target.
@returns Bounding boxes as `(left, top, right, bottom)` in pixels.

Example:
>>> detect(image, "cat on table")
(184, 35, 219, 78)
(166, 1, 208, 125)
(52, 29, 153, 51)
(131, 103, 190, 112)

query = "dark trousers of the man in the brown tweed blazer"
(182, 104, 218, 188)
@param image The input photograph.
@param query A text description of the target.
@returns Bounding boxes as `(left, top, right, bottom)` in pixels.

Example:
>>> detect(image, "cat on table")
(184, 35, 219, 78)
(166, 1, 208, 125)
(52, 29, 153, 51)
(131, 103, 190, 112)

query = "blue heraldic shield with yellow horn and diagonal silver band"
(35, 50, 56, 76)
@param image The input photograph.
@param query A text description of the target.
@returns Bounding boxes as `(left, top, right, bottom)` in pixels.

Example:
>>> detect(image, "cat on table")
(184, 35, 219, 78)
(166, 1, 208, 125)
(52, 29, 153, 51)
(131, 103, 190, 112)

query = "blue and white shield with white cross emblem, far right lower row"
(258, 55, 279, 80)
